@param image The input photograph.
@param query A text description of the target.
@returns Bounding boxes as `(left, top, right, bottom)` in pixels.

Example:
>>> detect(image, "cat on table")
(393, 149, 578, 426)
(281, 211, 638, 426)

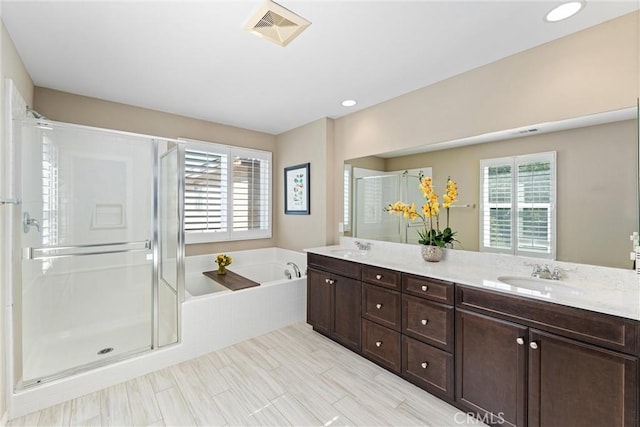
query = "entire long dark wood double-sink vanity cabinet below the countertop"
(307, 254, 640, 427)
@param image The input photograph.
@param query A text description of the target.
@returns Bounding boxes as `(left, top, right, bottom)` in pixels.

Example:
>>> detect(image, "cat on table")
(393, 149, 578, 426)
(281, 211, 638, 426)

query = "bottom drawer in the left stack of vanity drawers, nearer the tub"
(362, 319, 401, 373)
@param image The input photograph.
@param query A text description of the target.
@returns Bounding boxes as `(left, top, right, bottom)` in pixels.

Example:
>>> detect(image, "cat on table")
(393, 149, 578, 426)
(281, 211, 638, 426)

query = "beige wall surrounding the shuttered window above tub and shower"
(35, 87, 278, 255)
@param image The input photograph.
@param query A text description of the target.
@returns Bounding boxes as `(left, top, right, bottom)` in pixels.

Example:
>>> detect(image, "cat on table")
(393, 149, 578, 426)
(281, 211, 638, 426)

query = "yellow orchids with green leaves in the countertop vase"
(385, 172, 458, 248)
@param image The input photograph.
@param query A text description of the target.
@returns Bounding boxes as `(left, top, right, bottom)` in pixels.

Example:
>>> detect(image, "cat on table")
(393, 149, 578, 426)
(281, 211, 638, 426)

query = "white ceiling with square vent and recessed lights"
(1, 0, 640, 134)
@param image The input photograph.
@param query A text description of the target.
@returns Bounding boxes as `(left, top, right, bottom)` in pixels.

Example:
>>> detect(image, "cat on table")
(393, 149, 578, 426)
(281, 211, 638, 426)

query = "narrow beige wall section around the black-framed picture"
(274, 119, 342, 250)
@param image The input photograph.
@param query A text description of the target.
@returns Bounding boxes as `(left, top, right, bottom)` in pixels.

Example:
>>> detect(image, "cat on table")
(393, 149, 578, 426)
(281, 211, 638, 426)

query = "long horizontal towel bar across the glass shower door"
(22, 240, 153, 260)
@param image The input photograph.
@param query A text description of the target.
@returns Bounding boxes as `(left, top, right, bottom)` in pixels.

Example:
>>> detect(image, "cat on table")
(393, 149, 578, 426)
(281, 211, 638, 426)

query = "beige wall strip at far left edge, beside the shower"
(0, 19, 33, 419)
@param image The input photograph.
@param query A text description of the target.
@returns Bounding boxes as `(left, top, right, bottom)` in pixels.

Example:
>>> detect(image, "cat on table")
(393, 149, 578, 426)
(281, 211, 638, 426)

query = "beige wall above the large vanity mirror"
(331, 13, 640, 258)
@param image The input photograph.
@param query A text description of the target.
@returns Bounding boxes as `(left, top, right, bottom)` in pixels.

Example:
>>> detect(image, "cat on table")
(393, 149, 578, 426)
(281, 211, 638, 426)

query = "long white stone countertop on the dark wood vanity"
(305, 237, 640, 320)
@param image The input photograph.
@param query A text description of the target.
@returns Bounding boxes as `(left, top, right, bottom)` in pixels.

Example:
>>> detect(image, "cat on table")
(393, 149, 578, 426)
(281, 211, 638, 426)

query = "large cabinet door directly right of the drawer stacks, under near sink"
(456, 310, 528, 426)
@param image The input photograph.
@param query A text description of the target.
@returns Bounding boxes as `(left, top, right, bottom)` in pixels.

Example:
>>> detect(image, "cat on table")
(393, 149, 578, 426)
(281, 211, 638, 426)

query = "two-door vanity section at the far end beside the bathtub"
(307, 254, 362, 352)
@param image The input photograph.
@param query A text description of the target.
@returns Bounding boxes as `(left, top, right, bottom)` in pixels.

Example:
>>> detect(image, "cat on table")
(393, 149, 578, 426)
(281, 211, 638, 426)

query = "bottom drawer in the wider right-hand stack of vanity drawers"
(402, 336, 453, 399)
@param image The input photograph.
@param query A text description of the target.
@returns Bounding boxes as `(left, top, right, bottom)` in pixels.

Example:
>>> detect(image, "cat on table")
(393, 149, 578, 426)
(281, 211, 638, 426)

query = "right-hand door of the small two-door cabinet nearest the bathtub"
(331, 275, 362, 352)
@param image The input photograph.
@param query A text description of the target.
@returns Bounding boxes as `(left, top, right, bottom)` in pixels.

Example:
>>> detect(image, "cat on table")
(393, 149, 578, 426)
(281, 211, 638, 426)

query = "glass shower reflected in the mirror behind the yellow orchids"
(352, 167, 432, 243)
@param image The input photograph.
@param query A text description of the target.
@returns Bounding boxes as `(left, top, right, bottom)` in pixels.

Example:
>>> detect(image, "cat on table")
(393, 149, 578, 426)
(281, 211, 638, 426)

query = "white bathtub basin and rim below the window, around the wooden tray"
(185, 248, 307, 299)
